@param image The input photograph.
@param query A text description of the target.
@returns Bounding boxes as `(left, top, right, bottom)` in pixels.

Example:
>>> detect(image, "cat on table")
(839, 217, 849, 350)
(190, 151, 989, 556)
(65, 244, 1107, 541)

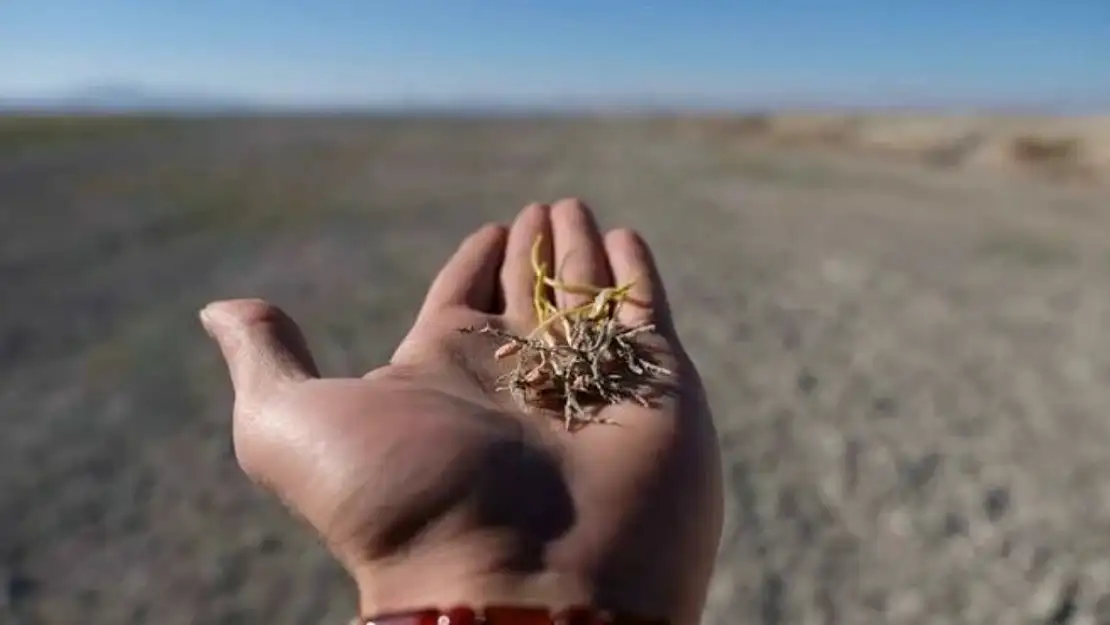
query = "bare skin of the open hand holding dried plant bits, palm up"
(201, 200, 723, 624)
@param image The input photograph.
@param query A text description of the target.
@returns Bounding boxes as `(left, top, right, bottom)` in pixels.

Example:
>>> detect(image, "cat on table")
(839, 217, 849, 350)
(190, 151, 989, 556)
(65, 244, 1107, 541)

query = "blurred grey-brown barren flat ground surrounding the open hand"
(0, 118, 1110, 625)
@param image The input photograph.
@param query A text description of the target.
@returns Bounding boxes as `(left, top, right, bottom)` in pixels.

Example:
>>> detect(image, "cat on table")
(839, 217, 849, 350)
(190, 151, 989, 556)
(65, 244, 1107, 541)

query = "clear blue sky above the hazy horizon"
(0, 0, 1110, 105)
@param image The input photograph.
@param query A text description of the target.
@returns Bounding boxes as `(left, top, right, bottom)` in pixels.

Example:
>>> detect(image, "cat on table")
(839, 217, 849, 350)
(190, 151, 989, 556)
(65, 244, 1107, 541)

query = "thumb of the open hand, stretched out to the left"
(200, 300, 320, 405)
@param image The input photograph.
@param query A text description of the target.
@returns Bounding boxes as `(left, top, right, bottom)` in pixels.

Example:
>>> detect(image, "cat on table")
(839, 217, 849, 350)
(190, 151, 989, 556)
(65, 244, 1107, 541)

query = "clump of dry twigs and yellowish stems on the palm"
(462, 238, 672, 431)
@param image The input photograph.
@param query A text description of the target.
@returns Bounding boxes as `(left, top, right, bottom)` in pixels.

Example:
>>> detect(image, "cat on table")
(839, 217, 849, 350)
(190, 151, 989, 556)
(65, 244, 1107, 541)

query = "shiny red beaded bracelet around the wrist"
(351, 605, 667, 625)
